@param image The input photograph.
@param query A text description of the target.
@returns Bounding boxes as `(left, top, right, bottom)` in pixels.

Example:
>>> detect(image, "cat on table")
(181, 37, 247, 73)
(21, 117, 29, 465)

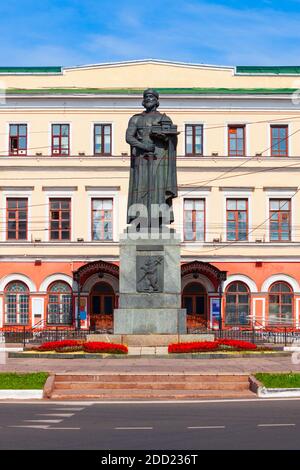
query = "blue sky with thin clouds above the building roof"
(0, 0, 300, 66)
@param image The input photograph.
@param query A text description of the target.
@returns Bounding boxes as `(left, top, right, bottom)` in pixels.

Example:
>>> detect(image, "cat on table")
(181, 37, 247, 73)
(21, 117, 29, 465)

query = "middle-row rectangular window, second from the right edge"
(226, 199, 248, 241)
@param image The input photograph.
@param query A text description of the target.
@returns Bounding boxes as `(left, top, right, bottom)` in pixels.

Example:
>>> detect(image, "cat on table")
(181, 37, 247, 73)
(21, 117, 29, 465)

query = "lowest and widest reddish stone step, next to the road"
(51, 389, 255, 400)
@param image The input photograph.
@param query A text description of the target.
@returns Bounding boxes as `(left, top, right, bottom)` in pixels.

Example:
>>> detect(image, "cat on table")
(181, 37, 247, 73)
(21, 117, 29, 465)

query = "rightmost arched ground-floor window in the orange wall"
(269, 282, 294, 325)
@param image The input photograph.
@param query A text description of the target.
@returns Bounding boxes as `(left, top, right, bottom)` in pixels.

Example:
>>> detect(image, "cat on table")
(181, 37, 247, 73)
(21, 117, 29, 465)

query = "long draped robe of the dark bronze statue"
(126, 111, 177, 224)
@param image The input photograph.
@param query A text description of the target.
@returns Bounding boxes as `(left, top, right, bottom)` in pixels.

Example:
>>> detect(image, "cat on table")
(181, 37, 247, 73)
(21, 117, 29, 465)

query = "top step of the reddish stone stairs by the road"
(55, 373, 248, 383)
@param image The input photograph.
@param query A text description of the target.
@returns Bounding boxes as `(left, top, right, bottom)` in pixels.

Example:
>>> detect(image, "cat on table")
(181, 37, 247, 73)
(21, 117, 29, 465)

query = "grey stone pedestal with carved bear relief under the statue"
(114, 233, 186, 334)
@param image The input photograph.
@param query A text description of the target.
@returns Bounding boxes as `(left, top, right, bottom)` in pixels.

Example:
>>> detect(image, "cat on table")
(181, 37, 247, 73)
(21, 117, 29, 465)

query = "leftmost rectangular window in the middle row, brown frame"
(6, 198, 28, 240)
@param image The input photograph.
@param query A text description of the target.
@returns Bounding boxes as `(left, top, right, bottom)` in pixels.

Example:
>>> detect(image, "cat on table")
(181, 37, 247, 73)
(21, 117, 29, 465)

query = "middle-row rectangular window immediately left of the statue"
(92, 199, 113, 240)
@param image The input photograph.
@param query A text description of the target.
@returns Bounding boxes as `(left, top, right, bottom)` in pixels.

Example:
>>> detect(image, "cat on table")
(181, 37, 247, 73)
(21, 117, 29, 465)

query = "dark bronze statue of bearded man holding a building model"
(126, 89, 178, 227)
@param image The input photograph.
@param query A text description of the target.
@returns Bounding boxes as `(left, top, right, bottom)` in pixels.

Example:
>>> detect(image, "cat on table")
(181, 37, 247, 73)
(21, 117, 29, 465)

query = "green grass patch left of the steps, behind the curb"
(0, 372, 49, 390)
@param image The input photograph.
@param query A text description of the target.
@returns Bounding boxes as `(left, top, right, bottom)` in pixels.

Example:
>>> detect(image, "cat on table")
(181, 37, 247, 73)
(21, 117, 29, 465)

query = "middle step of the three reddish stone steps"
(55, 380, 249, 391)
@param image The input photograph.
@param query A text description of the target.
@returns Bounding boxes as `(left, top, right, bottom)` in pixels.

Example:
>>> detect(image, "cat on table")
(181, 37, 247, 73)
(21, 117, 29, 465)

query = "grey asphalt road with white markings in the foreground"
(0, 399, 300, 450)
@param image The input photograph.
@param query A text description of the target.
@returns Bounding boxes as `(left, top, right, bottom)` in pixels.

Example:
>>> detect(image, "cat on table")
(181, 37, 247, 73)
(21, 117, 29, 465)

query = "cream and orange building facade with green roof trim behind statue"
(0, 60, 300, 331)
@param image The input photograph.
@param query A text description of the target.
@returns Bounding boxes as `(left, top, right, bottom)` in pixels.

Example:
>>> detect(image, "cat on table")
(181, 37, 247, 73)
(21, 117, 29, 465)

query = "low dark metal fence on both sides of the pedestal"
(0, 327, 300, 346)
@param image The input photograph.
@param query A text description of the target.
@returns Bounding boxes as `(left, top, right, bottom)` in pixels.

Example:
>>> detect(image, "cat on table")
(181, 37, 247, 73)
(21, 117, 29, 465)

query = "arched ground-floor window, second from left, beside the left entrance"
(47, 281, 72, 325)
